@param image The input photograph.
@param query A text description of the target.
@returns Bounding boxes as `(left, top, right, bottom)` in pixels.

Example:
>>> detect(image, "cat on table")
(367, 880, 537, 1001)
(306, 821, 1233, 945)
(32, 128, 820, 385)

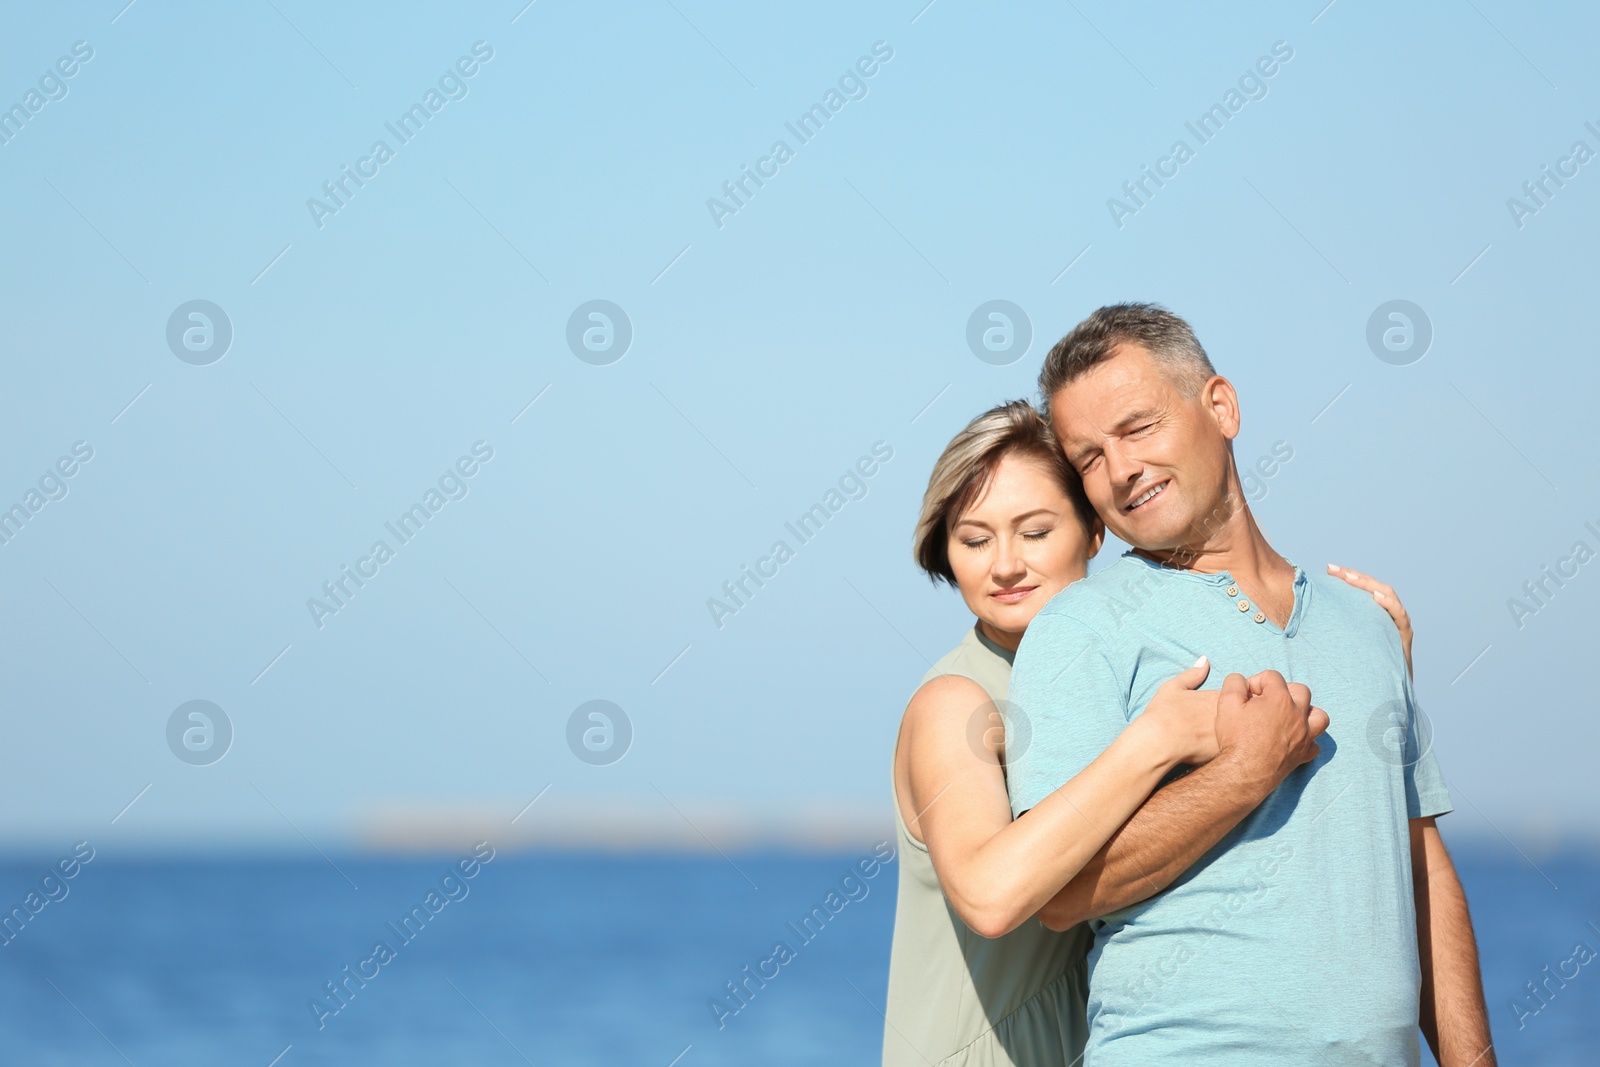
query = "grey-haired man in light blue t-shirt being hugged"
(1008, 304, 1494, 1067)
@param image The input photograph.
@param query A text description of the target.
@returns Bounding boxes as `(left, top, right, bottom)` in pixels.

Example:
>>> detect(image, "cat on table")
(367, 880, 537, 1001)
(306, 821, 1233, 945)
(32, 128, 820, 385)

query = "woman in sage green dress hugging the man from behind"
(883, 400, 1411, 1067)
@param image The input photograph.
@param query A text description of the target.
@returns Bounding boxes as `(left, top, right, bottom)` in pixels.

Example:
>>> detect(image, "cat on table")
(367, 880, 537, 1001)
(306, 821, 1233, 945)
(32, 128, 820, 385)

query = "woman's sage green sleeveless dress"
(883, 625, 1093, 1067)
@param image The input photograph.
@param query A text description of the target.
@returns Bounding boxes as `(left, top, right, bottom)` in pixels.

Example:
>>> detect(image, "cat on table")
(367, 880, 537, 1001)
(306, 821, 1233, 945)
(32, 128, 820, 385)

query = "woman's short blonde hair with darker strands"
(912, 400, 1099, 585)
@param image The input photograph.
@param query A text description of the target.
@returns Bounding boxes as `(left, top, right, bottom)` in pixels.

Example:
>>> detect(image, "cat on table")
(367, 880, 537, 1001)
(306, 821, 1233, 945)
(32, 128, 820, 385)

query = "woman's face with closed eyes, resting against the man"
(949, 453, 1106, 649)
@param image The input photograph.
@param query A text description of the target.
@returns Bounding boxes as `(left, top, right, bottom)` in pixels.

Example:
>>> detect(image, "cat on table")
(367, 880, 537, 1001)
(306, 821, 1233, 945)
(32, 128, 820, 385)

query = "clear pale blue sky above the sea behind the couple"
(0, 0, 1600, 849)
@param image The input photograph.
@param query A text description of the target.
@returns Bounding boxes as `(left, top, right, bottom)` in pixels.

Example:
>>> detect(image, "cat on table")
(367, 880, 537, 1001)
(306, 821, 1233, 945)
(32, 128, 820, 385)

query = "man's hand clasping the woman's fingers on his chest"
(1216, 670, 1328, 797)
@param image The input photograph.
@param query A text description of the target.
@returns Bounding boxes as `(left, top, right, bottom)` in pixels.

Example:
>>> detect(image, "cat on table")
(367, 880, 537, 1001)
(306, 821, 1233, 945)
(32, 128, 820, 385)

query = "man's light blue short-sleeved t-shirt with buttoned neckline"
(1006, 553, 1451, 1067)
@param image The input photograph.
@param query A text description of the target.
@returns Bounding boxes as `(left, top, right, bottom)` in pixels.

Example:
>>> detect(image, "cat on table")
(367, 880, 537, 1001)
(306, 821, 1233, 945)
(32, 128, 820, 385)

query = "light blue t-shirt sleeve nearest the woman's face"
(1002, 613, 1128, 817)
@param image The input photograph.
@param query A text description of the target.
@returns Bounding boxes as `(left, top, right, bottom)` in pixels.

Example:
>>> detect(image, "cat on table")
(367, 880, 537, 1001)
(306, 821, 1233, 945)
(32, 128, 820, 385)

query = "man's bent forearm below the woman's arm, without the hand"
(1038, 755, 1270, 929)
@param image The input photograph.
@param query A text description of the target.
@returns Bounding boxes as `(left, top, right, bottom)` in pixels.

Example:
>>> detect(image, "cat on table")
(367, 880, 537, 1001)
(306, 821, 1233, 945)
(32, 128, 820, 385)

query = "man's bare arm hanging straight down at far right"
(1411, 817, 1494, 1067)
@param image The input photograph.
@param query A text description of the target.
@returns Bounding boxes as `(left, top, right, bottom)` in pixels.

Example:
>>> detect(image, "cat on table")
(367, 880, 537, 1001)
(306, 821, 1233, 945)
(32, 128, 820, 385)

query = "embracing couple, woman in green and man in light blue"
(883, 304, 1494, 1067)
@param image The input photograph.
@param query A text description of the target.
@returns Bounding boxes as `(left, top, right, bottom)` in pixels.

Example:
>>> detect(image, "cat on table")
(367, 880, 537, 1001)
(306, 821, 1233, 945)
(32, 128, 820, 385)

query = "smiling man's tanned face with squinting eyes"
(1050, 344, 1238, 550)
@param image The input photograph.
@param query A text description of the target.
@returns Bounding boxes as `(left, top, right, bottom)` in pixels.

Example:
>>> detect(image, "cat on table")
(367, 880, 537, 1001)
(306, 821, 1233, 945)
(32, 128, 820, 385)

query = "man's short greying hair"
(1038, 304, 1216, 418)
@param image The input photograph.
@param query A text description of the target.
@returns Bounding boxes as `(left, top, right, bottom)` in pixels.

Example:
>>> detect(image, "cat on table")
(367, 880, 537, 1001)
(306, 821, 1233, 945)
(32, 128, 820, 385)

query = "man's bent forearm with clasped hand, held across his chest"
(1038, 670, 1328, 929)
